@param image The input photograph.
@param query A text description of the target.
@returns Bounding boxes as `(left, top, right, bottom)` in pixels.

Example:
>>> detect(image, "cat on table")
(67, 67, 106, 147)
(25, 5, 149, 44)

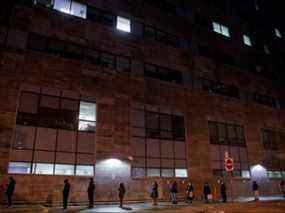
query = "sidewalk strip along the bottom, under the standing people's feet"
(0, 196, 285, 213)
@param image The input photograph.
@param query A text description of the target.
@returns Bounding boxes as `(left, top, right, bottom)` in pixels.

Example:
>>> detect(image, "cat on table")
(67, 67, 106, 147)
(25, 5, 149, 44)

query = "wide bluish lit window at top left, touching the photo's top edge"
(54, 0, 87, 19)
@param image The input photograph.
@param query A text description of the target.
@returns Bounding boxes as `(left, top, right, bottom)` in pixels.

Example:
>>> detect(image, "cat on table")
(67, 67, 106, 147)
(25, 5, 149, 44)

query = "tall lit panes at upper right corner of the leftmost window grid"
(78, 101, 96, 131)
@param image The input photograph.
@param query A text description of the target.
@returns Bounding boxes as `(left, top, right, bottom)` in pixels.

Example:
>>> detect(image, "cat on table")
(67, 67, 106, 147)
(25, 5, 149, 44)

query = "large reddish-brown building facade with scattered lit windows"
(0, 0, 285, 203)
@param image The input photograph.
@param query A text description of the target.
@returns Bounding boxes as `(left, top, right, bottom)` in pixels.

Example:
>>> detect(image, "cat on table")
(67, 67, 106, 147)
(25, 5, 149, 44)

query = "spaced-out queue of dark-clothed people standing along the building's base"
(2, 177, 285, 209)
